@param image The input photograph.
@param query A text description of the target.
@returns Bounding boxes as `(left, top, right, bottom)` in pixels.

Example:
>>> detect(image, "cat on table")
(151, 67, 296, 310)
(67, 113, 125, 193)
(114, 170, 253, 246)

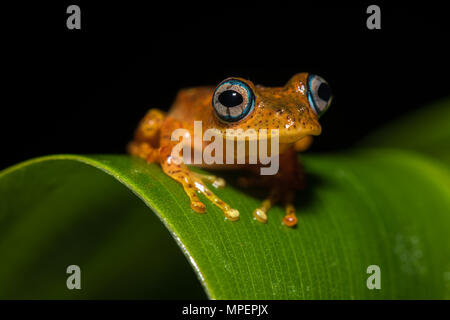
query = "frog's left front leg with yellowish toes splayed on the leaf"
(159, 117, 239, 221)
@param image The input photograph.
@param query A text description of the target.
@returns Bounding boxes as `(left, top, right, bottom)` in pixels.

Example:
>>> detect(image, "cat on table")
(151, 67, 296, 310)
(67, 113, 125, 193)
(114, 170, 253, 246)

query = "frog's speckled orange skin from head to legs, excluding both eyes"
(128, 73, 321, 227)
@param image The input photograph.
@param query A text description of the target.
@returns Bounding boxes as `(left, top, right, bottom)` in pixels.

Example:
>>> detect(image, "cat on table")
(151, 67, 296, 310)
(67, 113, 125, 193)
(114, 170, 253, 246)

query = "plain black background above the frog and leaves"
(0, 1, 449, 169)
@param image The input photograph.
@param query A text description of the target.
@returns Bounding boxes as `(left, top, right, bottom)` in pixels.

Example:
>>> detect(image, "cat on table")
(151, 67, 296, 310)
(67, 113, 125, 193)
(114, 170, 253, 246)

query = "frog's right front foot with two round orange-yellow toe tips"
(253, 188, 298, 227)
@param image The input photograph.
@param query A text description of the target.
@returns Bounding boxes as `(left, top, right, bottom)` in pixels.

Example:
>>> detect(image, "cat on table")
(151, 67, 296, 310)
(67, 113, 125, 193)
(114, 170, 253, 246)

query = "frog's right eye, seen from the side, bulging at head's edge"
(308, 74, 332, 117)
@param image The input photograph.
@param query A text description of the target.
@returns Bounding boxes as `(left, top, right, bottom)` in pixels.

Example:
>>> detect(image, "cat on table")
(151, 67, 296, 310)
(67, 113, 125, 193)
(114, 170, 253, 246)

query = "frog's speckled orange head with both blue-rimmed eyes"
(212, 73, 332, 143)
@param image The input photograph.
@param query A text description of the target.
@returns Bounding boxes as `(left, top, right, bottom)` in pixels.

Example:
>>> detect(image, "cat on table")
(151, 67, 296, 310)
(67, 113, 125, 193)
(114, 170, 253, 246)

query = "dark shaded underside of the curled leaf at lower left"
(0, 156, 205, 299)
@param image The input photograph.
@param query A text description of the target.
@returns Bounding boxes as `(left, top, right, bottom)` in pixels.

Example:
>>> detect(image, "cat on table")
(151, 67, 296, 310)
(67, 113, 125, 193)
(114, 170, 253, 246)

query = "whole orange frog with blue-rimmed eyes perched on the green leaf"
(127, 72, 333, 227)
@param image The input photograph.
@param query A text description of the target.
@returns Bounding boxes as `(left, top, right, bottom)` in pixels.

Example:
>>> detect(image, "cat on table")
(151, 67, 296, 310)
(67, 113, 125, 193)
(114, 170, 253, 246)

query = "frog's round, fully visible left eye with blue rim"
(212, 79, 255, 122)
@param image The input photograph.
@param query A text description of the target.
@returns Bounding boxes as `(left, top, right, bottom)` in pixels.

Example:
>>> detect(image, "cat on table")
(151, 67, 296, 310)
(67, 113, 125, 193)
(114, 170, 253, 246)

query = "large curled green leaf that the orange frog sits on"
(0, 149, 450, 299)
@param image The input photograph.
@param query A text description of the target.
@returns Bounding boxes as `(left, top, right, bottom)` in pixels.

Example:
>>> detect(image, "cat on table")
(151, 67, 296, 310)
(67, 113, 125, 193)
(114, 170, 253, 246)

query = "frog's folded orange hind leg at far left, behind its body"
(127, 109, 166, 162)
